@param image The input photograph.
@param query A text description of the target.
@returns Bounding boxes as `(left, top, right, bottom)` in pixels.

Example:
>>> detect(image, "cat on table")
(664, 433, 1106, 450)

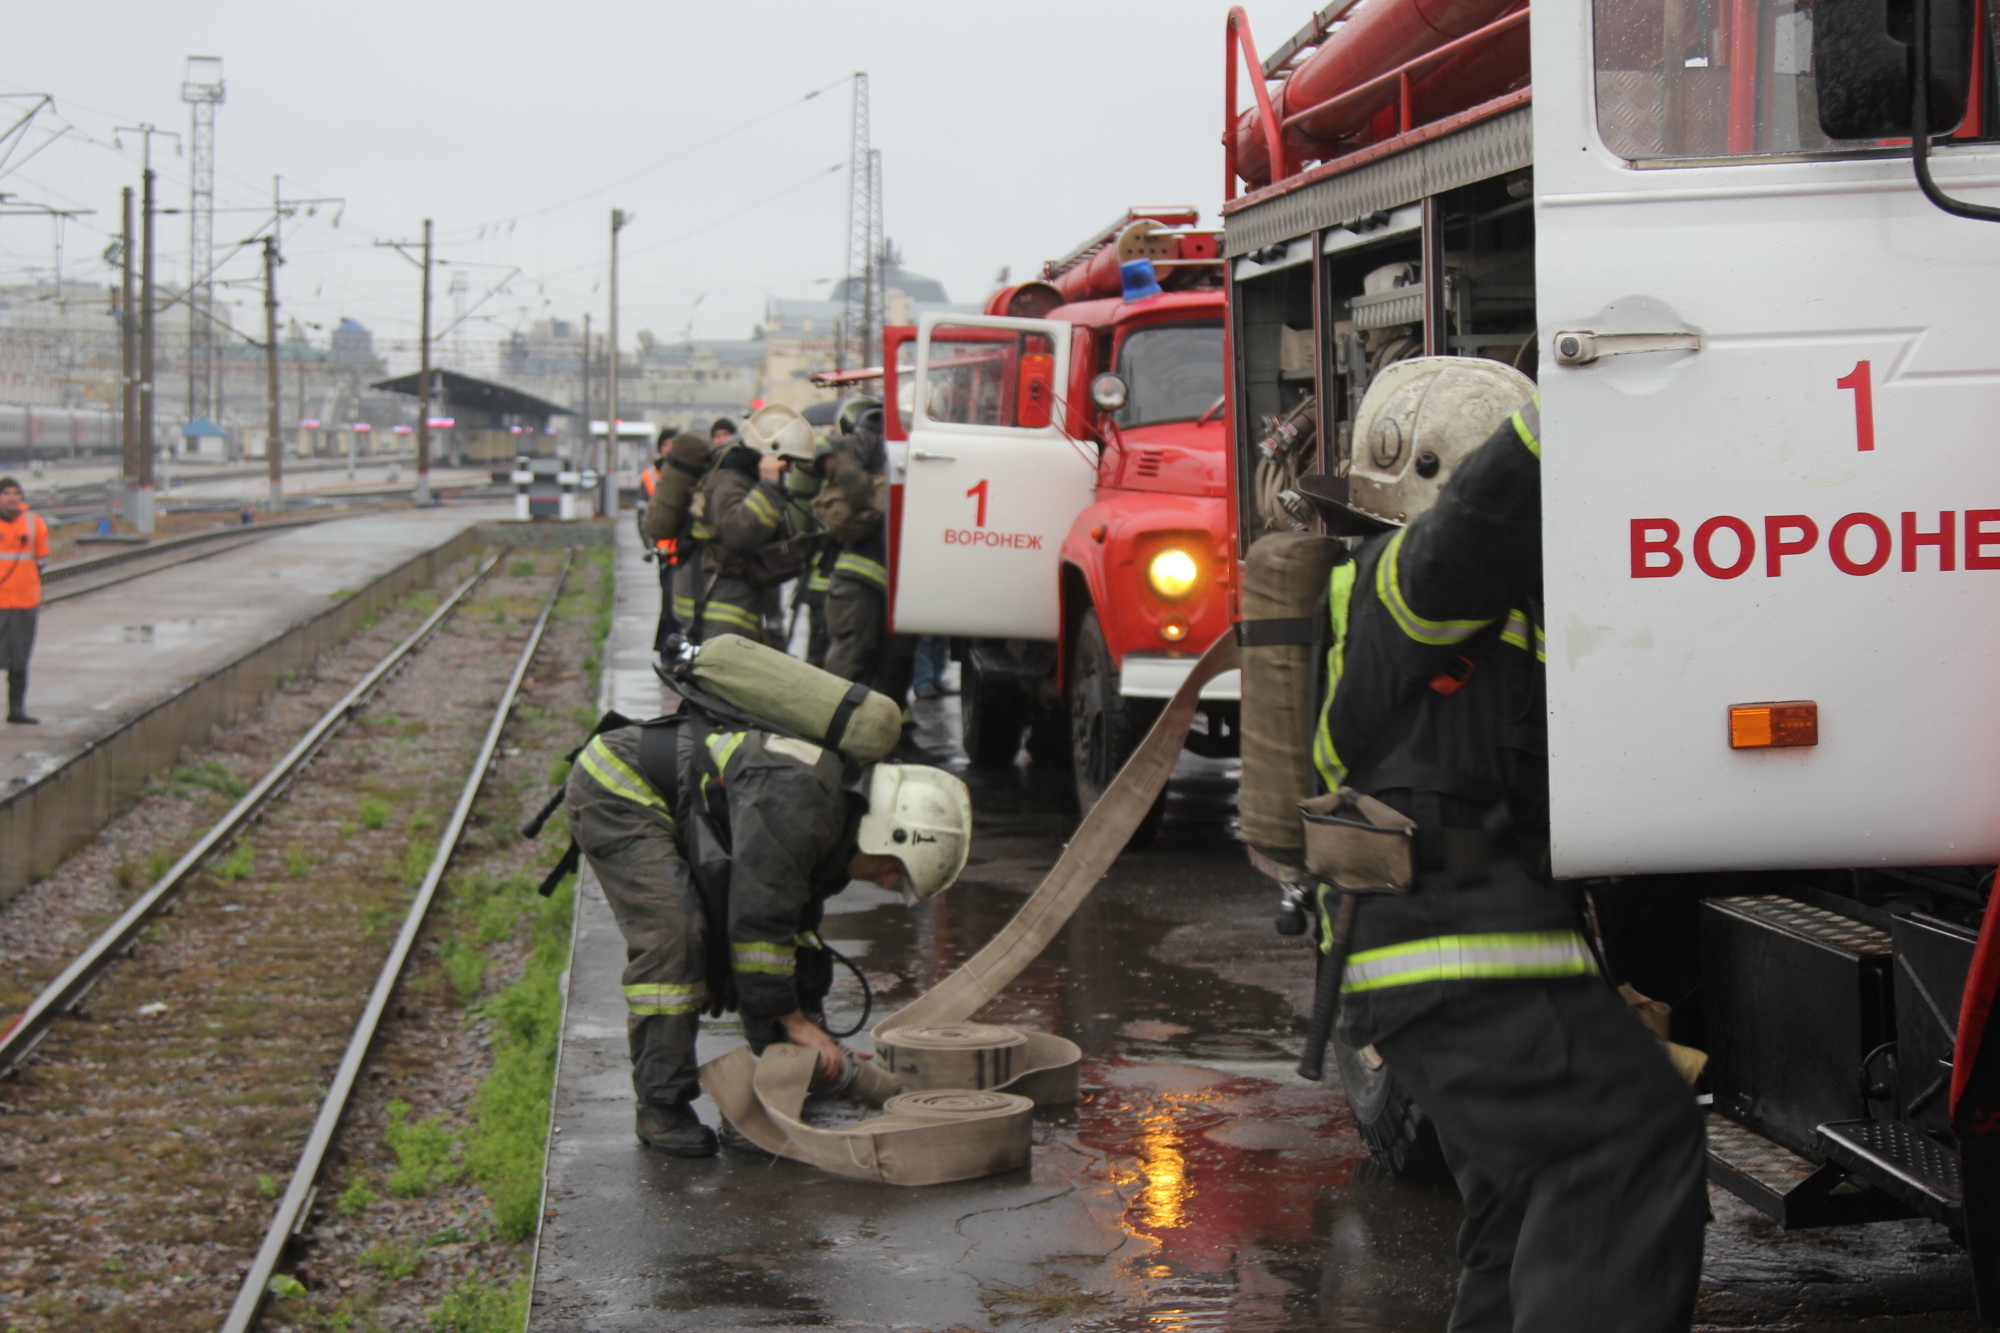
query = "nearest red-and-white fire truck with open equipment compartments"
(1222, 0, 2000, 1321)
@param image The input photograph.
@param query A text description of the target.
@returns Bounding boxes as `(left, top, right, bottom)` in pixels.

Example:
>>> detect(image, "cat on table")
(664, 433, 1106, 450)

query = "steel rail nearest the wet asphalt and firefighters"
(222, 554, 576, 1333)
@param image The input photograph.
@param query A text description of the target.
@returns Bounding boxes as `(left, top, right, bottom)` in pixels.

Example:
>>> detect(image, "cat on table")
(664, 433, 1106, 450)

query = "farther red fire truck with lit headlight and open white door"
(884, 208, 1238, 811)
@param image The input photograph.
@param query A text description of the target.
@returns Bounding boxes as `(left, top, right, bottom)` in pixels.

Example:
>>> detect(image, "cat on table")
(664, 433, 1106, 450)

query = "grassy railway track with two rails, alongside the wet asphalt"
(0, 544, 568, 1329)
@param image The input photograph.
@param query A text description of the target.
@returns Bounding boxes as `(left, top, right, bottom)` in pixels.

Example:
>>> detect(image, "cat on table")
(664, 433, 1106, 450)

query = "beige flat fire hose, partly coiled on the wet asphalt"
(702, 634, 1240, 1185)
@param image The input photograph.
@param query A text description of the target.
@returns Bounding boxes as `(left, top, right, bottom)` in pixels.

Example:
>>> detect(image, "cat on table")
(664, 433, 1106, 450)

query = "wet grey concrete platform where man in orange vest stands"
(0, 504, 512, 793)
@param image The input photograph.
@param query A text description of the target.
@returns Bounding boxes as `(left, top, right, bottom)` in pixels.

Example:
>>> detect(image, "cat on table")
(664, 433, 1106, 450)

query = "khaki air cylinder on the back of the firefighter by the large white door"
(1236, 532, 1346, 879)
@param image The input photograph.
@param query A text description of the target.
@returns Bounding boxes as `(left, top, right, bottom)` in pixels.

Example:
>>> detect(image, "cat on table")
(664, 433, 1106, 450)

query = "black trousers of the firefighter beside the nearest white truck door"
(1376, 977, 1708, 1333)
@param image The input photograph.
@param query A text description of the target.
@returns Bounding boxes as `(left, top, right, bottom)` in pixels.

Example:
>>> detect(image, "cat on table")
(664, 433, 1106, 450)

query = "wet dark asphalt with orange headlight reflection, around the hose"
(530, 680, 1978, 1333)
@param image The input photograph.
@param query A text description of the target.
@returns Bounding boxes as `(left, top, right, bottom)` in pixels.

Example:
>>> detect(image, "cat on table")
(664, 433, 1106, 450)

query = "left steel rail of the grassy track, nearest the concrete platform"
(0, 554, 500, 1079)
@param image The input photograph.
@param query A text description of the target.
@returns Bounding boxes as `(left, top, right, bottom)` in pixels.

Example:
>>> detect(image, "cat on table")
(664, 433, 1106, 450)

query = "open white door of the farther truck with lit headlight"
(894, 314, 1096, 638)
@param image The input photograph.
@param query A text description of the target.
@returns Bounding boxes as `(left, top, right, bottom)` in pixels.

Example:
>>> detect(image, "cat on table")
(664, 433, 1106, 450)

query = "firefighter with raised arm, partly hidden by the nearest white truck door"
(1308, 358, 1706, 1333)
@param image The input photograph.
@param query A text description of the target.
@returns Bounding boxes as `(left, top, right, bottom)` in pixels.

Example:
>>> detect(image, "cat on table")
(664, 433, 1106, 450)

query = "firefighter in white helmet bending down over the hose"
(564, 713, 972, 1157)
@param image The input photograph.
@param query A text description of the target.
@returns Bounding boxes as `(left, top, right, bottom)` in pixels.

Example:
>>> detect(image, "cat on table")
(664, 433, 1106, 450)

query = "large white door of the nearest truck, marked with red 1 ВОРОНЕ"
(1532, 0, 2000, 877)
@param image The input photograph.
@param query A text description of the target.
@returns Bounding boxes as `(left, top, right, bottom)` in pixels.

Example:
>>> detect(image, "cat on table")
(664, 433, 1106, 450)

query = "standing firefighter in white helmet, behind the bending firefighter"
(674, 402, 816, 642)
